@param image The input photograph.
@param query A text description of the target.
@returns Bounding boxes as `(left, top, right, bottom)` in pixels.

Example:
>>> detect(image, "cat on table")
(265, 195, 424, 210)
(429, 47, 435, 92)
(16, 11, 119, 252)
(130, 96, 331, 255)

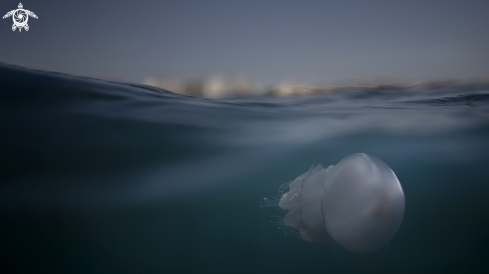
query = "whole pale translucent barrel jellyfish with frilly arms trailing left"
(266, 153, 405, 254)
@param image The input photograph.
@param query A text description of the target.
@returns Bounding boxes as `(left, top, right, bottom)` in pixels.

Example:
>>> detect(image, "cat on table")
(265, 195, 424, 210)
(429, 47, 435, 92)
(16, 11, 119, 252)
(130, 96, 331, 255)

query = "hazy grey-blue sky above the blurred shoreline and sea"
(0, 0, 489, 83)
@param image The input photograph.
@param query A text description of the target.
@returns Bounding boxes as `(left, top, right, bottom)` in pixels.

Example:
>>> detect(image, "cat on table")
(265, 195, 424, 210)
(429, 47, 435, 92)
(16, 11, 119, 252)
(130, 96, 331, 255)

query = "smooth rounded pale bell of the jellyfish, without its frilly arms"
(321, 153, 405, 253)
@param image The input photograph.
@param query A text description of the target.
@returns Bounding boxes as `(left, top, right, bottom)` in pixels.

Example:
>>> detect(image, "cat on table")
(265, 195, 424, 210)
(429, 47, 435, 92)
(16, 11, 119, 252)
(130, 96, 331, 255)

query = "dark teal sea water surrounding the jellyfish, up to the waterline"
(0, 64, 489, 273)
